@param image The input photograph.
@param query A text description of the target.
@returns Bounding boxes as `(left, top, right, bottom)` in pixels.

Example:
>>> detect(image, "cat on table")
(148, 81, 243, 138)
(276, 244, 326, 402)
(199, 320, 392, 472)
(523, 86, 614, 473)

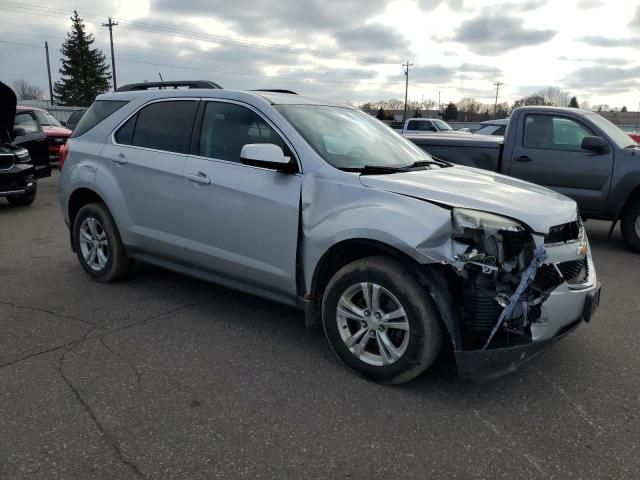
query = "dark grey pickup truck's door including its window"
(506, 113, 613, 213)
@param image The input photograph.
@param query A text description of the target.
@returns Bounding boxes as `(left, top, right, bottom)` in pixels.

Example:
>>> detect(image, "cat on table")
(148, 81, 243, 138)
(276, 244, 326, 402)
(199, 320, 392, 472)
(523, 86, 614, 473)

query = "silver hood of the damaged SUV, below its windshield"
(360, 166, 577, 233)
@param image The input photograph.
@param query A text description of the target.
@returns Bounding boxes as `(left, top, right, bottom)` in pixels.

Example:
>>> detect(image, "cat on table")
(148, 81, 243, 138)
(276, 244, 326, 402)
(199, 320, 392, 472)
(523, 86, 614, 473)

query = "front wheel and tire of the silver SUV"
(322, 257, 442, 384)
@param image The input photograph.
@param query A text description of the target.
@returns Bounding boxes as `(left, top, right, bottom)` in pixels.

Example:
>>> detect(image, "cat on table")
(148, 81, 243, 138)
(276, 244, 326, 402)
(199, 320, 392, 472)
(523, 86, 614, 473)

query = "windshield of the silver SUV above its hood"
(275, 105, 431, 169)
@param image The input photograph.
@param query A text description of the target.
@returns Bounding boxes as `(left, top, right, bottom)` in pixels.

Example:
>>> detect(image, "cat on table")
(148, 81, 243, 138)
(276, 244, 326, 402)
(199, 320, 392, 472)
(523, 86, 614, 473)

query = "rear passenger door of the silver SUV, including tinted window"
(98, 98, 199, 259)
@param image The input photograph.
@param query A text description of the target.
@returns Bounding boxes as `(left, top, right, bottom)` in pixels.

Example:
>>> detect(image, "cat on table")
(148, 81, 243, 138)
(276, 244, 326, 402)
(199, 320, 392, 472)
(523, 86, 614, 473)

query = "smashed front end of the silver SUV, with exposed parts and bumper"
(438, 209, 600, 380)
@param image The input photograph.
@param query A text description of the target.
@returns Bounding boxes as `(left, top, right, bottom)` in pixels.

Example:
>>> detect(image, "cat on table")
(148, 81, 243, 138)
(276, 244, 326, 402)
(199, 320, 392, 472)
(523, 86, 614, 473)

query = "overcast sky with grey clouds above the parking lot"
(0, 0, 640, 110)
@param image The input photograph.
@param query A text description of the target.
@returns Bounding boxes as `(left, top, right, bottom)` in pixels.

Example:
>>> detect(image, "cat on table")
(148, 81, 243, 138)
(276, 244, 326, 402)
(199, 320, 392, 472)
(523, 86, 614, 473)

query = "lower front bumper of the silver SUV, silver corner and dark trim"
(455, 282, 600, 381)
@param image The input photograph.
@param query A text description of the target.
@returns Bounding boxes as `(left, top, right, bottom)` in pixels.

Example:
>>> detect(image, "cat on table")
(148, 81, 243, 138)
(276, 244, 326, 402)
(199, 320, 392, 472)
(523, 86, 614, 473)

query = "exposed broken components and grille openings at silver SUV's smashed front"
(455, 221, 588, 349)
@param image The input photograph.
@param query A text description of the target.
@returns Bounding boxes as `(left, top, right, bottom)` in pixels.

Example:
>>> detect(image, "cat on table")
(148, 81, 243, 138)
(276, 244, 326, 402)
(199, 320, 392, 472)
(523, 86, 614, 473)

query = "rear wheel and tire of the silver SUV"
(73, 203, 130, 283)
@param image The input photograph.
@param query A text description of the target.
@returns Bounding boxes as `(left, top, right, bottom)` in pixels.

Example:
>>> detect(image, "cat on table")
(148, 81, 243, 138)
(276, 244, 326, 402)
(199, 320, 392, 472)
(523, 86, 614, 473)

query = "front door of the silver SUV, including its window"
(183, 100, 301, 298)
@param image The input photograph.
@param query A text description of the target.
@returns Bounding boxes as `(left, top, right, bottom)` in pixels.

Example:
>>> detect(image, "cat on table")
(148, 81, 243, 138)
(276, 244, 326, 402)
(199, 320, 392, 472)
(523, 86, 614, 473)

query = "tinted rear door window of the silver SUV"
(131, 100, 198, 153)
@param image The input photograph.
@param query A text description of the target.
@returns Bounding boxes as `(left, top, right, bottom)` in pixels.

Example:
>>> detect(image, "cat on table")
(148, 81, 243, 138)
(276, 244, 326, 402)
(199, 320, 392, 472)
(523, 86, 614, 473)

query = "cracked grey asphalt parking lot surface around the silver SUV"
(0, 175, 640, 480)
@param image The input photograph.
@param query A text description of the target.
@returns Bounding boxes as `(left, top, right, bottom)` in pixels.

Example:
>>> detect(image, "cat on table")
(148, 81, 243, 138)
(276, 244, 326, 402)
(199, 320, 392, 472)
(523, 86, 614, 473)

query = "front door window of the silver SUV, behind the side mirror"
(198, 102, 292, 162)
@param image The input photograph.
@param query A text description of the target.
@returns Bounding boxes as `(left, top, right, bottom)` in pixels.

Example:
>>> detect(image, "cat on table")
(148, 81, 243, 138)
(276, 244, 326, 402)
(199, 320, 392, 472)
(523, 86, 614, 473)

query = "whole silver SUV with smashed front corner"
(60, 85, 600, 383)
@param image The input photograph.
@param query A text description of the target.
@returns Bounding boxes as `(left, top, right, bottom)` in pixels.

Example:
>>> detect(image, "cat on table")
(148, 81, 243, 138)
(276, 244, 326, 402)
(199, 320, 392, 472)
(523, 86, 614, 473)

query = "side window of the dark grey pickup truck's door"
(524, 115, 593, 151)
